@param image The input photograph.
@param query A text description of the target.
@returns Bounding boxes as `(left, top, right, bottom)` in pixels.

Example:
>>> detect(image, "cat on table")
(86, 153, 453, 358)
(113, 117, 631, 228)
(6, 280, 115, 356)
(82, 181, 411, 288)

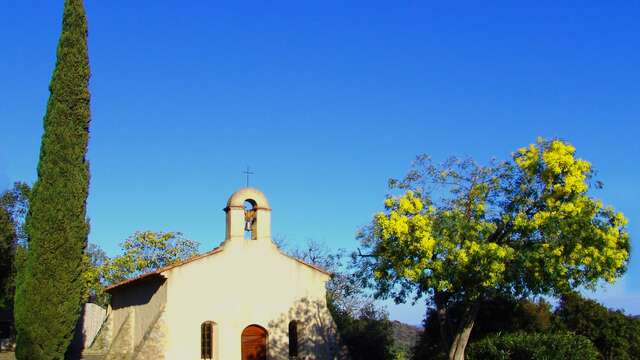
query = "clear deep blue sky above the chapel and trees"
(0, 0, 640, 324)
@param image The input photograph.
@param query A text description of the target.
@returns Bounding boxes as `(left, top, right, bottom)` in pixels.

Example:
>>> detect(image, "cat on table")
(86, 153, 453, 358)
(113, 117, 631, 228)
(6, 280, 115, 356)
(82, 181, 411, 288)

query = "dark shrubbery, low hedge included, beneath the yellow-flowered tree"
(413, 293, 640, 360)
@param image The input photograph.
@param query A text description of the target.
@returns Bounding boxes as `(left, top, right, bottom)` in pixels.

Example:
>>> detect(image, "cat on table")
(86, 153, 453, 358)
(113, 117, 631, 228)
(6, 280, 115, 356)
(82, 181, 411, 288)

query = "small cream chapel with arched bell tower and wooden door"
(84, 187, 347, 360)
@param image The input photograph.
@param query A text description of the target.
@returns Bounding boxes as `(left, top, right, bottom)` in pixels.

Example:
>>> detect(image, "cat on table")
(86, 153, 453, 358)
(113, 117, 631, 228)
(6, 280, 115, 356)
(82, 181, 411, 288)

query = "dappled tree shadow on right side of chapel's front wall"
(269, 298, 349, 360)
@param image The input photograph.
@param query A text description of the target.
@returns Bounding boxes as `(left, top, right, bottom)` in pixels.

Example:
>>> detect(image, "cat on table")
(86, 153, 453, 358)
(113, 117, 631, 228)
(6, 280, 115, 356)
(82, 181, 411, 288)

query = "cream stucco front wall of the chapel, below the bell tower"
(163, 239, 336, 360)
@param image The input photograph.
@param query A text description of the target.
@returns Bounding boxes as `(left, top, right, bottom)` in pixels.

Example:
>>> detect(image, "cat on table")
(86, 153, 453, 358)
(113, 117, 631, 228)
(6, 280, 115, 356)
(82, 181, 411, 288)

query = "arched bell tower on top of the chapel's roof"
(224, 187, 271, 242)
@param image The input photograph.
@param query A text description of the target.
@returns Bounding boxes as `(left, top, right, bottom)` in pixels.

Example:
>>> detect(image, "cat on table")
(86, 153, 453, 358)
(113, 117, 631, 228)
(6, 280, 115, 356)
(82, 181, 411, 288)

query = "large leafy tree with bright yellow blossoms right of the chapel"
(358, 139, 630, 359)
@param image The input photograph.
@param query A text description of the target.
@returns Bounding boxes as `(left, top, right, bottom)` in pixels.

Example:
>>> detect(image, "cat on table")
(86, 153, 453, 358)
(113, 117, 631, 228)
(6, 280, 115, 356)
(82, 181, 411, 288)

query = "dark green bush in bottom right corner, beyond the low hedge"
(555, 293, 640, 360)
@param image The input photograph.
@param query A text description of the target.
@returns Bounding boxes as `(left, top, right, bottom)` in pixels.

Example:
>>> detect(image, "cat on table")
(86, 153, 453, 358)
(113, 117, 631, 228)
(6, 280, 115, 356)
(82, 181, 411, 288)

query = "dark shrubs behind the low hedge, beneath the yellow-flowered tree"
(414, 293, 640, 360)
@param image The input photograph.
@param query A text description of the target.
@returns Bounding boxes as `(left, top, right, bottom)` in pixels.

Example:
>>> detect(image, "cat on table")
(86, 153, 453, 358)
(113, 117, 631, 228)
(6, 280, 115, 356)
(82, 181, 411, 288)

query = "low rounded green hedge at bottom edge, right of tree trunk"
(467, 332, 598, 360)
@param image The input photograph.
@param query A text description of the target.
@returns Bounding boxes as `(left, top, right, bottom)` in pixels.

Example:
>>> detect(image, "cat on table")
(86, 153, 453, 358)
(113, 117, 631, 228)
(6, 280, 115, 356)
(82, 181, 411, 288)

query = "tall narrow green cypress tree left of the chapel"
(15, 0, 90, 360)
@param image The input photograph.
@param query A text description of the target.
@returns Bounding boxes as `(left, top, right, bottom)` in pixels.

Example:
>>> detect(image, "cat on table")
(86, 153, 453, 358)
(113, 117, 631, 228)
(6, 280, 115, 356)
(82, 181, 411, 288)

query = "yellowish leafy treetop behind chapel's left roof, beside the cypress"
(99, 231, 199, 284)
